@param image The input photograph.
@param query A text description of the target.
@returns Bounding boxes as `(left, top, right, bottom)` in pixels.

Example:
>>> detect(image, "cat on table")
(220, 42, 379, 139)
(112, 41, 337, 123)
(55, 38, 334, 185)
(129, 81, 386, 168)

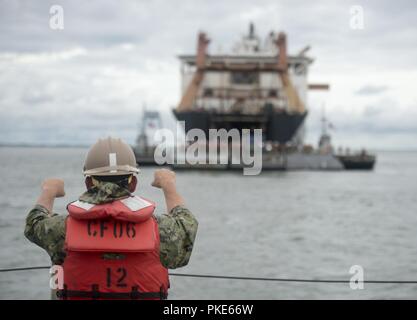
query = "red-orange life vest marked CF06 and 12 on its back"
(57, 196, 169, 299)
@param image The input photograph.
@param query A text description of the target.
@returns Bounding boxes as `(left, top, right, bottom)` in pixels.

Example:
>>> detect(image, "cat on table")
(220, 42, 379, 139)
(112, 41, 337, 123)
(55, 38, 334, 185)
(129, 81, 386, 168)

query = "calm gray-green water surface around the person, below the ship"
(0, 148, 417, 299)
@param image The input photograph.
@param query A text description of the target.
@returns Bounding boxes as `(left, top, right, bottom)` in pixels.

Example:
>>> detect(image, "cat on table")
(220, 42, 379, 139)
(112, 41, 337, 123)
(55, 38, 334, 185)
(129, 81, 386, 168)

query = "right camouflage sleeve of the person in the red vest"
(156, 206, 198, 269)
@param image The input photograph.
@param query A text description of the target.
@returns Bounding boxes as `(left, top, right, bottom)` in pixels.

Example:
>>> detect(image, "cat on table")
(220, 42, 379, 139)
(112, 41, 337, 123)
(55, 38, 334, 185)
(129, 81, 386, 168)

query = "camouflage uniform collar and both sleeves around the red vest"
(25, 182, 198, 269)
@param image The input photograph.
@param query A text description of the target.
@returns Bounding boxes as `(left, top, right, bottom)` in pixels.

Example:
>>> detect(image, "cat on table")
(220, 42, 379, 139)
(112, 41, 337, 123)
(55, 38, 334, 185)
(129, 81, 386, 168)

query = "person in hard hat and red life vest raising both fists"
(25, 137, 198, 299)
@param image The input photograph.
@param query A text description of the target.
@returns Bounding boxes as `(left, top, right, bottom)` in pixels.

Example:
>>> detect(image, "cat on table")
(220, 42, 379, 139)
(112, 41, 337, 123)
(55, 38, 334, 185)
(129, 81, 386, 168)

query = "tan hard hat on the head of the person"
(84, 137, 139, 176)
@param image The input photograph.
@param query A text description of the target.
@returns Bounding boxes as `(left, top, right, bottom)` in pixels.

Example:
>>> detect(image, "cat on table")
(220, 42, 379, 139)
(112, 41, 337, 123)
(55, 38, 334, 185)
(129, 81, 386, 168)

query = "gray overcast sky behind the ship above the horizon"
(0, 0, 417, 149)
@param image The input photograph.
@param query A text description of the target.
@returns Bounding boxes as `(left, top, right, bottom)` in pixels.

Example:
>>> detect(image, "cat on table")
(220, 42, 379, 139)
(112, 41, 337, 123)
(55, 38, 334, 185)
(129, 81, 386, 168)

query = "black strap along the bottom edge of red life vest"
(56, 284, 168, 300)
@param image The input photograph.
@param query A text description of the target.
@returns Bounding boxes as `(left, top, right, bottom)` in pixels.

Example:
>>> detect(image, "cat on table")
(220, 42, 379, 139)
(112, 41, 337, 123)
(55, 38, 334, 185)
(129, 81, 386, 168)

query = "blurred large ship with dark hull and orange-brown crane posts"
(174, 24, 328, 145)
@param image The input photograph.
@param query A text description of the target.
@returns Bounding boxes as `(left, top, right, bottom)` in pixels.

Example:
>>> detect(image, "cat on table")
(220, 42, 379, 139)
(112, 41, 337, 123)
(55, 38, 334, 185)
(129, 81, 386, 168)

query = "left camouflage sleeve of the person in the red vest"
(25, 205, 65, 264)
